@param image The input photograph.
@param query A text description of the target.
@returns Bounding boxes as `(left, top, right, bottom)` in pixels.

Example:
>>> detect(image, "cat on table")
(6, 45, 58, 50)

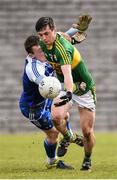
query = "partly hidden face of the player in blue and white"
(32, 45, 46, 61)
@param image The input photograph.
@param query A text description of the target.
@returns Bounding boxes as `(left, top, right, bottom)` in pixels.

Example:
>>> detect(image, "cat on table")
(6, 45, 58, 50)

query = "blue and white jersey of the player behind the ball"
(20, 56, 53, 107)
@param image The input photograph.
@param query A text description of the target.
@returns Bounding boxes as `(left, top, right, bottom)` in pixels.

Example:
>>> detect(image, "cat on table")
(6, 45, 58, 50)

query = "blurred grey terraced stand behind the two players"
(0, 0, 117, 133)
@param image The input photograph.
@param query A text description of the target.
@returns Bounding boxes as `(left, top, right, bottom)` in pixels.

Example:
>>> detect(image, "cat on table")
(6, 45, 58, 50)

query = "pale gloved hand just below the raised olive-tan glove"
(71, 32, 87, 44)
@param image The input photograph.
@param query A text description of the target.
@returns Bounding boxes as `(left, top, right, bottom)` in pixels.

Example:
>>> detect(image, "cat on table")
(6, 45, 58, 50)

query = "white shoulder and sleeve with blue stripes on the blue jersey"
(25, 56, 46, 84)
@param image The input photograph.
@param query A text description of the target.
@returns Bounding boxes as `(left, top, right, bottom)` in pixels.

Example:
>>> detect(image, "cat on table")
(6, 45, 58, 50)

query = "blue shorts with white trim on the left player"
(20, 99, 53, 130)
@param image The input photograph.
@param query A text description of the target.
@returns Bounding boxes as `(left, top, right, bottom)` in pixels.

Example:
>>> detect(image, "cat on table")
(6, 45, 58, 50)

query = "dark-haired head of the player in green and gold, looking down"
(35, 17, 56, 46)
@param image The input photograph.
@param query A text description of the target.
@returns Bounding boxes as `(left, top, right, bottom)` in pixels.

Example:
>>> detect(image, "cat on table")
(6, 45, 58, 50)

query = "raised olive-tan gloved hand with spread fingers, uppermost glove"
(72, 15, 92, 32)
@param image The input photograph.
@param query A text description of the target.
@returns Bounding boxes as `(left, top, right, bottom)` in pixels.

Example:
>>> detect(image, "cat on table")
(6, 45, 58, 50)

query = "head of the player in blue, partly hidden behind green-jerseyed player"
(24, 35, 45, 60)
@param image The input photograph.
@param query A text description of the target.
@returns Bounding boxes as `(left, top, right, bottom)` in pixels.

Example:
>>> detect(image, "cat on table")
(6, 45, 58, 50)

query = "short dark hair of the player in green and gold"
(35, 16, 55, 32)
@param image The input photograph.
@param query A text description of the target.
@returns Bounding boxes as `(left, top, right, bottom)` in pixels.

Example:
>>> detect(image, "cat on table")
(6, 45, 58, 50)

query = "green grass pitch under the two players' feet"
(0, 133, 117, 179)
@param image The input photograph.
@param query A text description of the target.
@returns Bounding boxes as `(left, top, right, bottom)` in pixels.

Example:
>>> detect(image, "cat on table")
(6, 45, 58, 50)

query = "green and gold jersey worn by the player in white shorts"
(40, 34, 94, 92)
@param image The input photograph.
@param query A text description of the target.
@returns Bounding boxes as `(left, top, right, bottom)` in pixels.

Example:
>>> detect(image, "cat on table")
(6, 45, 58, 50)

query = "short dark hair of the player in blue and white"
(24, 35, 39, 53)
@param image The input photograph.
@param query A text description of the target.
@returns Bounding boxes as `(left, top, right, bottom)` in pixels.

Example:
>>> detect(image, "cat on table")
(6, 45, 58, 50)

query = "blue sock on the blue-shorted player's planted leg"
(44, 139, 57, 158)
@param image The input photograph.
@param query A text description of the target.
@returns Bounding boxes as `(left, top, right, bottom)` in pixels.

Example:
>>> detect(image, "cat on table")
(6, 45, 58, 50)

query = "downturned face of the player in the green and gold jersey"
(38, 25, 56, 47)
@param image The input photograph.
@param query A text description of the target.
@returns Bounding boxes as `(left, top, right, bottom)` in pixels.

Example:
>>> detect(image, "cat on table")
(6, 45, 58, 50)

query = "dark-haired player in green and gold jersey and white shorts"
(35, 16, 96, 170)
